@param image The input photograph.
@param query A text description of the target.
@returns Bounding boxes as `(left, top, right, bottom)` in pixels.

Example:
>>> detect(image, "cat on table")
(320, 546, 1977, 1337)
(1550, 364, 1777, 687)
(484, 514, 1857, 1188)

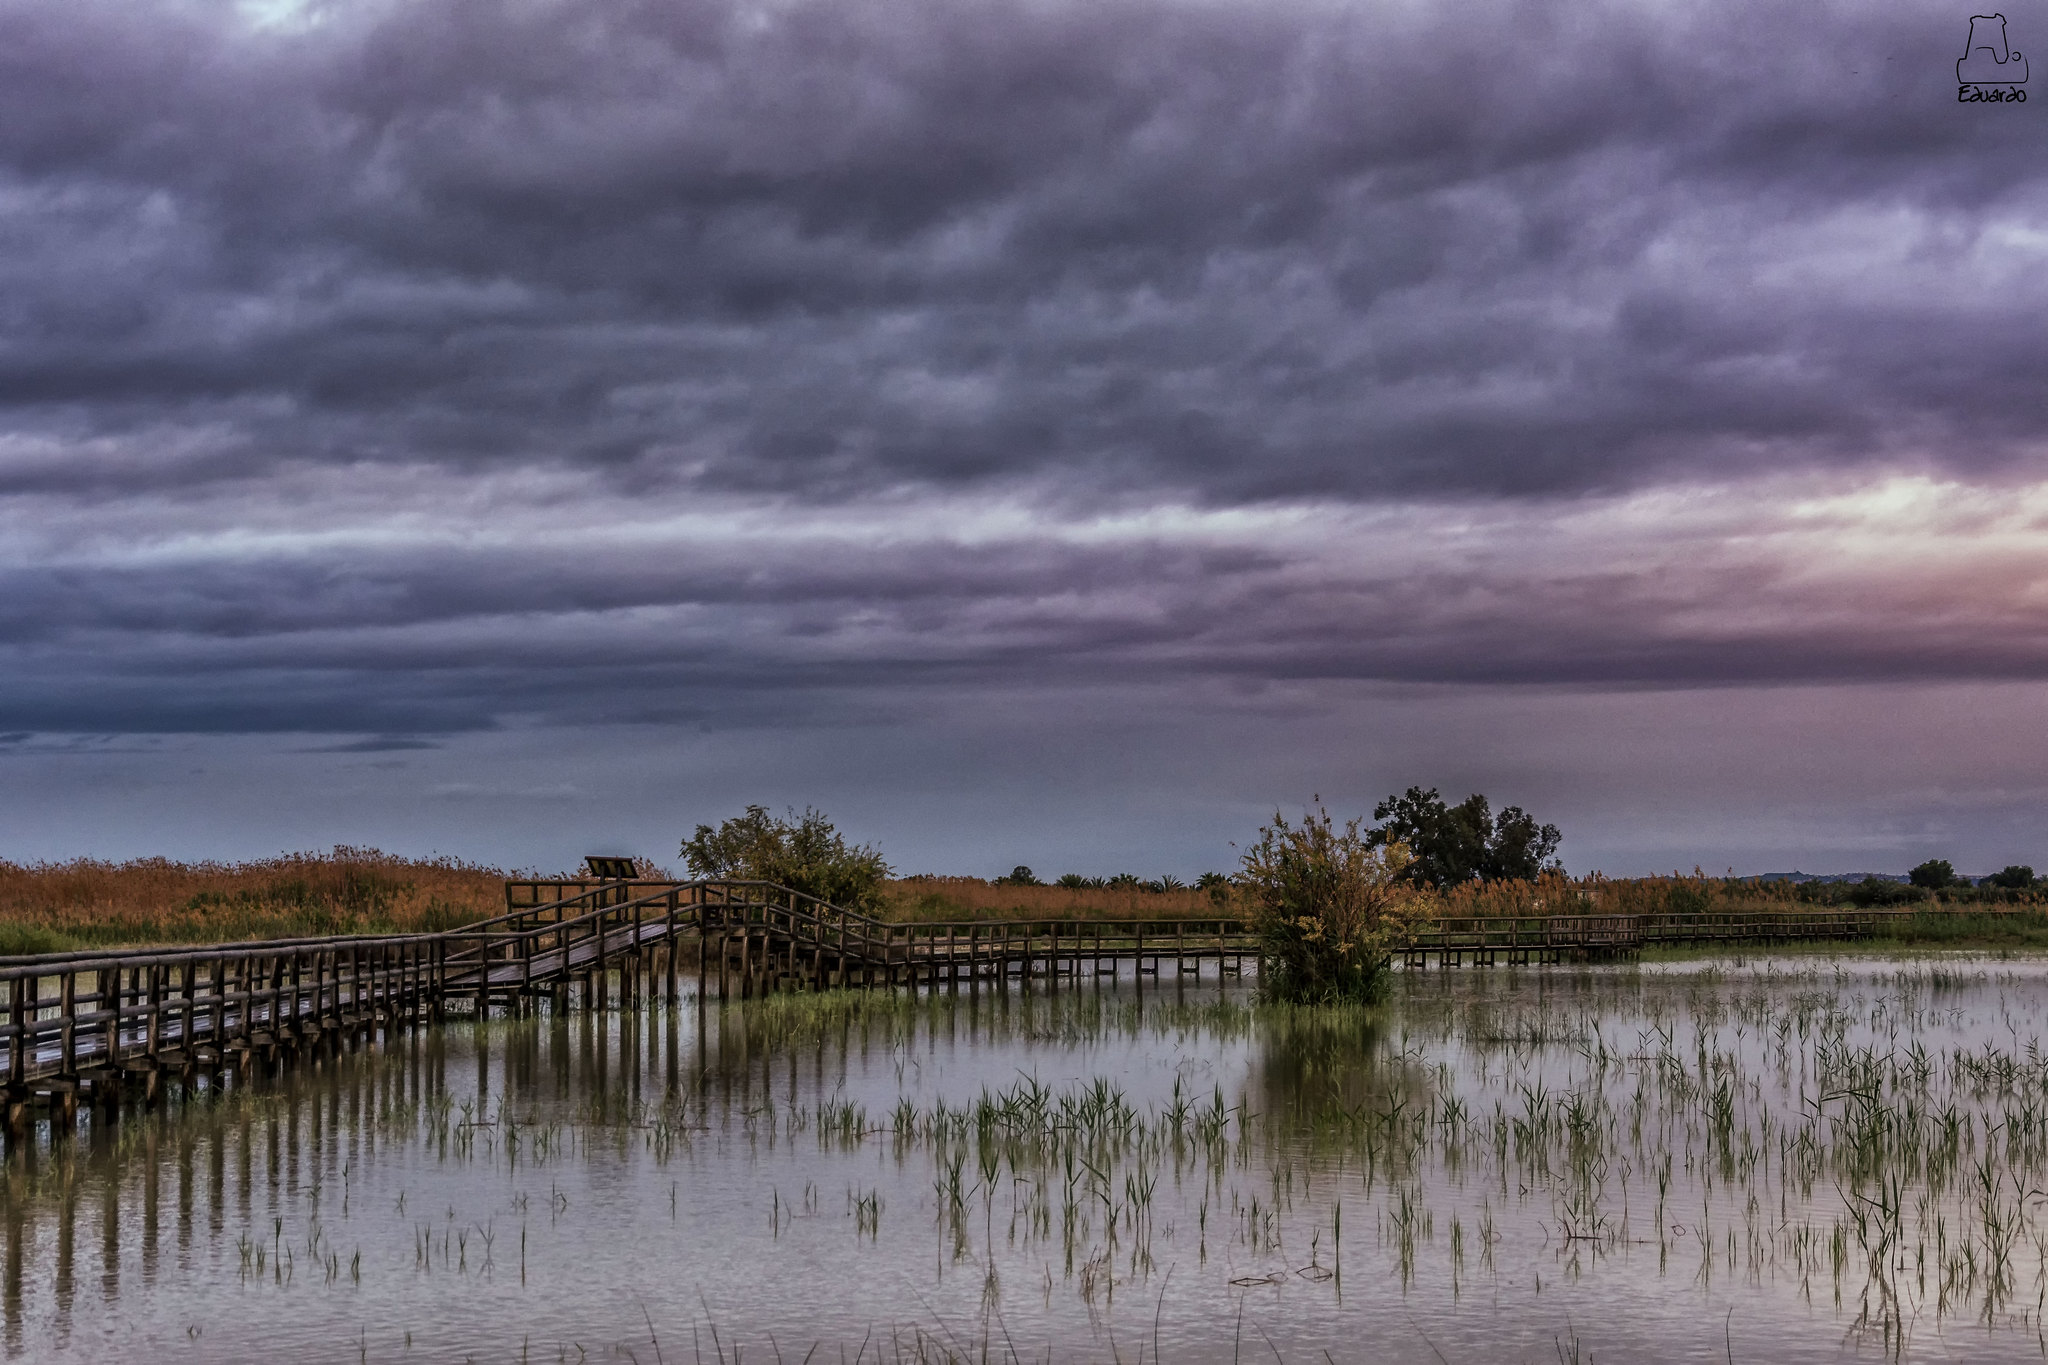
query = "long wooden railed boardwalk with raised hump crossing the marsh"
(0, 882, 1898, 1130)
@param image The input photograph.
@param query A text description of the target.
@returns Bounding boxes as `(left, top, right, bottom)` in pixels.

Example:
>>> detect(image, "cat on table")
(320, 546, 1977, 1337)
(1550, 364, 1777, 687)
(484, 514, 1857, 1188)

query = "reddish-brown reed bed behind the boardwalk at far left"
(0, 847, 506, 954)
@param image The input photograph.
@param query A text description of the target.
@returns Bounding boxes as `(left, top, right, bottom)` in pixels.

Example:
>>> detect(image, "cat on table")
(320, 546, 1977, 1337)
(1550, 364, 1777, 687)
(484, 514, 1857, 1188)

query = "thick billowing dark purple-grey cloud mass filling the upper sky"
(0, 0, 2048, 501)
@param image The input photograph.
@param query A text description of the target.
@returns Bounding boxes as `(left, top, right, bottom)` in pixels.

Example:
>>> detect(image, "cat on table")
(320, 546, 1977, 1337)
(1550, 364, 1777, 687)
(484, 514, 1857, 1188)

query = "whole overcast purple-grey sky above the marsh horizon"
(0, 0, 2048, 876)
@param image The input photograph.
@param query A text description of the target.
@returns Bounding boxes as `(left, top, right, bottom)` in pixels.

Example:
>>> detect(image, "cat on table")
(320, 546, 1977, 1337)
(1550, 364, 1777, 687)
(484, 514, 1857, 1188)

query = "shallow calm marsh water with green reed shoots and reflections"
(0, 958, 2048, 1365)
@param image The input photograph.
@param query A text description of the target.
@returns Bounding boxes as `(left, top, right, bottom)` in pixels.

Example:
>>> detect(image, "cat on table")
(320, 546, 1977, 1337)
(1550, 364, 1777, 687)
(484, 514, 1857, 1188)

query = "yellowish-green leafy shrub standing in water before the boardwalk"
(1237, 806, 1425, 1001)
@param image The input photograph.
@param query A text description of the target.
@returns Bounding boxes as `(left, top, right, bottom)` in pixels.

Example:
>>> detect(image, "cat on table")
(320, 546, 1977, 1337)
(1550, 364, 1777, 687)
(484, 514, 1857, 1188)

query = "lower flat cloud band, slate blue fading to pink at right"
(12, 480, 2048, 732)
